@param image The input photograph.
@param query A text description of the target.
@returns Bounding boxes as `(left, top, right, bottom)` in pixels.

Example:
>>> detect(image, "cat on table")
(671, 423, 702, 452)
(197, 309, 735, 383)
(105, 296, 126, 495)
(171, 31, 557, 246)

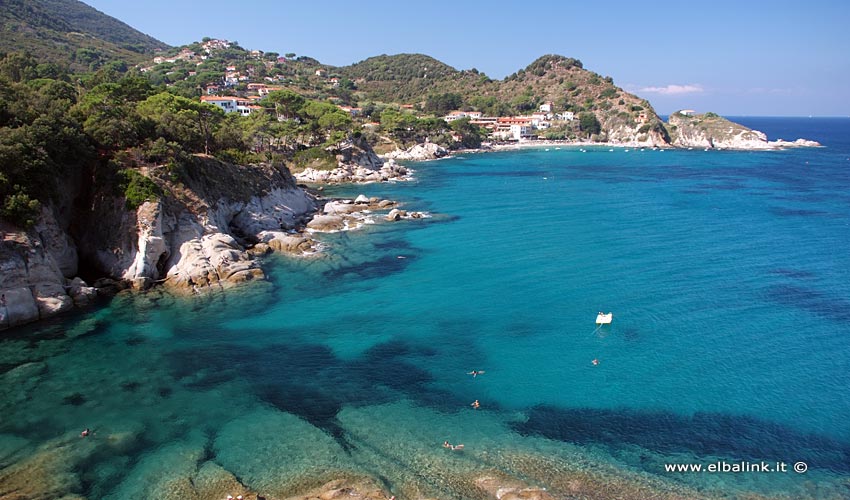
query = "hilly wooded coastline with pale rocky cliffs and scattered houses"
(0, 0, 817, 329)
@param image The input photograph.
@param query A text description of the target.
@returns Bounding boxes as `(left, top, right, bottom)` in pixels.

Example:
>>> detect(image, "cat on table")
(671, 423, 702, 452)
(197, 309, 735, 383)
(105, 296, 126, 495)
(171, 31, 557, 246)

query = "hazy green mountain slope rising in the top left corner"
(0, 0, 168, 71)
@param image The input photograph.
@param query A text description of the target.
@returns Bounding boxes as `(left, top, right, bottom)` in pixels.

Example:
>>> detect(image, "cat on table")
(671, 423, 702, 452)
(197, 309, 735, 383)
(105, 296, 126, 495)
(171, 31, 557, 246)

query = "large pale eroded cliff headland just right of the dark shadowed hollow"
(73, 157, 317, 293)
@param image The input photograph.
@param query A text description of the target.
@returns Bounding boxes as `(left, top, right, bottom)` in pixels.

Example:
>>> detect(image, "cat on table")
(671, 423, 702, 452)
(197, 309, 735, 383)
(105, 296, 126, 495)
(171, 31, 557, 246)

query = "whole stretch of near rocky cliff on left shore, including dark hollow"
(0, 157, 317, 329)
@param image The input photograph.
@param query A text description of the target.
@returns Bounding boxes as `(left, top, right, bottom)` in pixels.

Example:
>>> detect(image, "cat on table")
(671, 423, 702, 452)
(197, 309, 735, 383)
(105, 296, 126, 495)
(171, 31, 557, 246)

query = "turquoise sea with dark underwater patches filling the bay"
(0, 117, 850, 499)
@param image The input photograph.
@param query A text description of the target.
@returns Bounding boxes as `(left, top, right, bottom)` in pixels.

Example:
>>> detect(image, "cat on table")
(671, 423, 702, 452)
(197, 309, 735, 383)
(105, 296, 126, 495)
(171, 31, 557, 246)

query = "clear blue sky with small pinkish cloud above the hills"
(84, 0, 850, 116)
